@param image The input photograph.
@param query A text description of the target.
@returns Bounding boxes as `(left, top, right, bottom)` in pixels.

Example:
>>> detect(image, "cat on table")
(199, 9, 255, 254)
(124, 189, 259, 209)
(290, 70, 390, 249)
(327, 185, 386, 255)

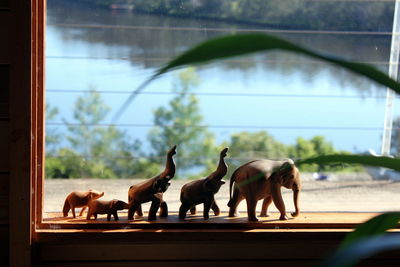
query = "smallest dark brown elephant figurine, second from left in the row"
(86, 199, 129, 221)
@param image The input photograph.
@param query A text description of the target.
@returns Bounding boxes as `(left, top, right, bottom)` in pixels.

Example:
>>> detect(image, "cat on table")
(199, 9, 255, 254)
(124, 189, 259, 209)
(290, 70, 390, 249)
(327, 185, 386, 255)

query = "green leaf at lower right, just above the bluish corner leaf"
(340, 212, 400, 248)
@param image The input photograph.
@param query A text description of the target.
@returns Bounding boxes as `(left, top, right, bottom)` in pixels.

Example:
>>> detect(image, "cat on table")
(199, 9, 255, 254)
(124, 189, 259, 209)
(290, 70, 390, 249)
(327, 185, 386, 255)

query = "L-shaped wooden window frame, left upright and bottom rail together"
(10, 0, 400, 266)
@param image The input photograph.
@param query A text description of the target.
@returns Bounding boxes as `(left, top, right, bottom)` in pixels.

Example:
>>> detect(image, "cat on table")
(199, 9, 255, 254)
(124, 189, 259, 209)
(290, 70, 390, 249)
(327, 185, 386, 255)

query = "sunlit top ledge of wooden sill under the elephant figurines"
(38, 212, 396, 232)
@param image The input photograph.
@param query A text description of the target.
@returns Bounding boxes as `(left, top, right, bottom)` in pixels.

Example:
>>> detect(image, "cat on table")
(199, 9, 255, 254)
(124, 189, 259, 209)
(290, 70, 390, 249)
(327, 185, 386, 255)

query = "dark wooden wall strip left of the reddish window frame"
(0, 0, 31, 266)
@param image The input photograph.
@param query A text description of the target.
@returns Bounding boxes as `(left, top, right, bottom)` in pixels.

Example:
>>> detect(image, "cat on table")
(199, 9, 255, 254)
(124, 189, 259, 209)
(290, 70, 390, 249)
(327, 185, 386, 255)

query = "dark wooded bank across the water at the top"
(70, 0, 395, 31)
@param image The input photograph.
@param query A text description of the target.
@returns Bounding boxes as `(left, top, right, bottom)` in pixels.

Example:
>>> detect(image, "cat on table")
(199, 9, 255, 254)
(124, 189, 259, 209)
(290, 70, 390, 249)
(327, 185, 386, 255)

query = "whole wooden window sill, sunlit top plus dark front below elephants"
(35, 212, 400, 266)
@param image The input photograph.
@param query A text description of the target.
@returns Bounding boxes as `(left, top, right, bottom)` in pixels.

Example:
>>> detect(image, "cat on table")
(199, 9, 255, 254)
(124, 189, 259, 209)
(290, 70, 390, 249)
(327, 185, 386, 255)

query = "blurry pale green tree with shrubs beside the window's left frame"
(46, 89, 160, 178)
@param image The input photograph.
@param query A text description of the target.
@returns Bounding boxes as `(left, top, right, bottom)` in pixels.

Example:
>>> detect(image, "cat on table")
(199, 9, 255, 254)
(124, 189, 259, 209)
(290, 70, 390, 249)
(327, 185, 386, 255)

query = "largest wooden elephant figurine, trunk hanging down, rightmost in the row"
(228, 159, 301, 221)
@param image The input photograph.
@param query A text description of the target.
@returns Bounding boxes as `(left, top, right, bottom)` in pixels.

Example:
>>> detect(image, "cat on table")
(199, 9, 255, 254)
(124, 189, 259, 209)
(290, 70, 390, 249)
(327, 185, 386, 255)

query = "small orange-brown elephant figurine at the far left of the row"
(63, 189, 104, 218)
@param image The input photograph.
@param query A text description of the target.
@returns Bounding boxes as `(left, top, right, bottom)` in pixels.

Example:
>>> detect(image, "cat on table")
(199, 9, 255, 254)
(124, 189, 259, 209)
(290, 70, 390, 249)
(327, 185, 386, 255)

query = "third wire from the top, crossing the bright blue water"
(46, 89, 385, 99)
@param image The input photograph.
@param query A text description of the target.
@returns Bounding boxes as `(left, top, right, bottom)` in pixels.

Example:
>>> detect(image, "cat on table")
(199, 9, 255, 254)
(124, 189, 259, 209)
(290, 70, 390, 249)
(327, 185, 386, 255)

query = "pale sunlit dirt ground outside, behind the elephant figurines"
(44, 174, 400, 212)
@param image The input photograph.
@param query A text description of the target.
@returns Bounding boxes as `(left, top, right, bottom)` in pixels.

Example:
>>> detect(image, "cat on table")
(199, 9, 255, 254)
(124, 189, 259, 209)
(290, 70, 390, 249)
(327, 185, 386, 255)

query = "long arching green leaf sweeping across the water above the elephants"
(113, 33, 400, 121)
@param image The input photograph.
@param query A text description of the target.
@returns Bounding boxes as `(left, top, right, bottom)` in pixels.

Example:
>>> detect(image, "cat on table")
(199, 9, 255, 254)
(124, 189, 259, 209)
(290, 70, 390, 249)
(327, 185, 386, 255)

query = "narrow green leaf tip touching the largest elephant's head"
(296, 154, 400, 172)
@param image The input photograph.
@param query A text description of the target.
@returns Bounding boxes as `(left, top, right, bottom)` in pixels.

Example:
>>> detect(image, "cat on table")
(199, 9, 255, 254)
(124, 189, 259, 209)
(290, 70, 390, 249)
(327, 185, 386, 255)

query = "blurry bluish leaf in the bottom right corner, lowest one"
(318, 237, 400, 267)
